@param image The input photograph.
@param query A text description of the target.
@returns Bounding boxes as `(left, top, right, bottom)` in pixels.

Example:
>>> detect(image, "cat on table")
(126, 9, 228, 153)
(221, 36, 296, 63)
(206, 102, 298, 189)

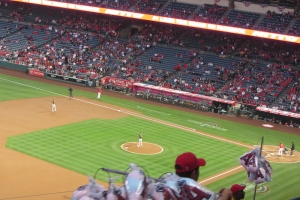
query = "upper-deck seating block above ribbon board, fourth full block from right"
(160, 2, 197, 19)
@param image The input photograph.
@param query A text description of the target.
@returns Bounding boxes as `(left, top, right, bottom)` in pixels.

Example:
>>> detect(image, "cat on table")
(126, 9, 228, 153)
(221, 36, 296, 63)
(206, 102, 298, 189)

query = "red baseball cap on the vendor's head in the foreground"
(175, 152, 206, 172)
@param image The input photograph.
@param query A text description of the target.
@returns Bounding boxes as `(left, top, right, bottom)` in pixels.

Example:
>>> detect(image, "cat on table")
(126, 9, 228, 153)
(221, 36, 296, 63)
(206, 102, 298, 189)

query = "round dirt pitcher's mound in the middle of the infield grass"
(121, 142, 164, 155)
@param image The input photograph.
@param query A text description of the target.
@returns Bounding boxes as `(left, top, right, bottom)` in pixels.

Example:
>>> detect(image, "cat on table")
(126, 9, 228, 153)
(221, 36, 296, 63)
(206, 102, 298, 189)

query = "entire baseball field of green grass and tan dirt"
(0, 69, 300, 200)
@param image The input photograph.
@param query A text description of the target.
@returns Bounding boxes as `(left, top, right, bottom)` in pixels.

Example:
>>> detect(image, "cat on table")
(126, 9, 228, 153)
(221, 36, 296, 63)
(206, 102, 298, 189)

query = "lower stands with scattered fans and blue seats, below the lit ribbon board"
(0, 1, 300, 112)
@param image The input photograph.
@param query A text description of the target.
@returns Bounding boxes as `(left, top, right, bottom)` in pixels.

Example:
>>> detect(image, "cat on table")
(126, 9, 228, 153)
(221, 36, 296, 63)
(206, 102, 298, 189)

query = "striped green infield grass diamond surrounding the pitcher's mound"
(6, 117, 246, 181)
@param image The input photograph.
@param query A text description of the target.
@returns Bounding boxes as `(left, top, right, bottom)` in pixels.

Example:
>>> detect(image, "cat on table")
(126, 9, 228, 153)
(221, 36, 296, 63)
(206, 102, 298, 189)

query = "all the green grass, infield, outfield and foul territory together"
(0, 74, 300, 199)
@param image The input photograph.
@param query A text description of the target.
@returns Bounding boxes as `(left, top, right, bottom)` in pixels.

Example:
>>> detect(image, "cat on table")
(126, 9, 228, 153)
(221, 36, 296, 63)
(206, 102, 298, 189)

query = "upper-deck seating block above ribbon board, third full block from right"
(192, 4, 227, 23)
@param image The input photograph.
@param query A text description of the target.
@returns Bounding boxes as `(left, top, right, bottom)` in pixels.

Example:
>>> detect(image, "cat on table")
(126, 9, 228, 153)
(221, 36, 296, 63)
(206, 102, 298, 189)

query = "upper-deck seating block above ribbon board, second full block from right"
(221, 10, 260, 28)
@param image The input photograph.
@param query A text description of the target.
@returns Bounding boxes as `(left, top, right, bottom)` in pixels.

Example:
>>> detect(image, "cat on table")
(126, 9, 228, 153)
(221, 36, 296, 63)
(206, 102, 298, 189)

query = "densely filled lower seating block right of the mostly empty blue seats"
(223, 62, 293, 106)
